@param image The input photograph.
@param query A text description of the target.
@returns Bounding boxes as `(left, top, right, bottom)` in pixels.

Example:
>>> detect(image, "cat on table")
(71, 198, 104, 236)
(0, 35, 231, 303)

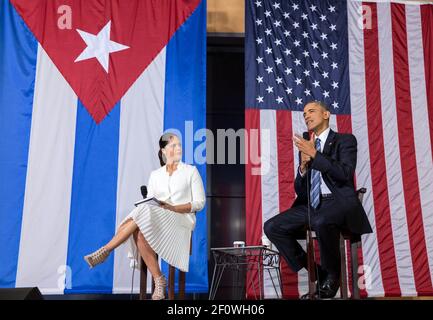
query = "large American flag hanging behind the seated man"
(245, 0, 433, 297)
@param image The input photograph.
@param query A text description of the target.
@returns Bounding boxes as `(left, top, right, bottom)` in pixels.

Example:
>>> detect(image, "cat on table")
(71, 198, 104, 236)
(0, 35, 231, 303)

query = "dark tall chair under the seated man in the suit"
(298, 188, 367, 299)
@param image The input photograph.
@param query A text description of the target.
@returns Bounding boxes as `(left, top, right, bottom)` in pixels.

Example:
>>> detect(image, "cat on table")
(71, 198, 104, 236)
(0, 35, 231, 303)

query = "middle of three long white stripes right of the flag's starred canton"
(377, 3, 416, 295)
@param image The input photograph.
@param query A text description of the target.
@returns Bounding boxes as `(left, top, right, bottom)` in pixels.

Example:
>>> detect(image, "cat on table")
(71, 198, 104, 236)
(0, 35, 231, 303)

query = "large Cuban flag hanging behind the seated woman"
(0, 0, 208, 294)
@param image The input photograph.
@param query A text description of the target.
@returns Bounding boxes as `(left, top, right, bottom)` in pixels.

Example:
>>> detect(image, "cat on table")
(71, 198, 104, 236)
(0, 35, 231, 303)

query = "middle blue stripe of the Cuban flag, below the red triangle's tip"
(65, 101, 120, 293)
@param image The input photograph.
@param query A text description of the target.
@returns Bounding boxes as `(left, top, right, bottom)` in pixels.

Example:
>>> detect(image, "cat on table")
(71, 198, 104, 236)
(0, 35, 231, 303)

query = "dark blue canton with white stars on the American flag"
(252, 0, 341, 108)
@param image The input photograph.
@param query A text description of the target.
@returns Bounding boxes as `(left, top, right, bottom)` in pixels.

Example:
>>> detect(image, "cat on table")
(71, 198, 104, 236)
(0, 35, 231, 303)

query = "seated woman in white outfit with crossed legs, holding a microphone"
(84, 133, 206, 300)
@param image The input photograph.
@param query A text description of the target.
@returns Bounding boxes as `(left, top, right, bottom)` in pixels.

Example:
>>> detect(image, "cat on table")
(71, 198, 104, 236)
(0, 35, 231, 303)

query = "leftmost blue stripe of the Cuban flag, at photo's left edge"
(0, 1, 38, 287)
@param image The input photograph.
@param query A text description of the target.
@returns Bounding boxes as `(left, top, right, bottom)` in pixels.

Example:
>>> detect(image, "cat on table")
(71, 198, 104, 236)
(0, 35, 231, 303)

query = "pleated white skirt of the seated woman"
(121, 204, 195, 272)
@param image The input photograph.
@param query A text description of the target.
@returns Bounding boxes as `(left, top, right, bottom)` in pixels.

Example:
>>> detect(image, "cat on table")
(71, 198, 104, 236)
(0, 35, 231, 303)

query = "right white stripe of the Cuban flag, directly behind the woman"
(113, 48, 166, 293)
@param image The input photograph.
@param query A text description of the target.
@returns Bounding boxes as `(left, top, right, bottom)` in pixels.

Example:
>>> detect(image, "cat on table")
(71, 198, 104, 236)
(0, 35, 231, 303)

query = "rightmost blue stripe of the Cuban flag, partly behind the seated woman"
(163, 0, 208, 292)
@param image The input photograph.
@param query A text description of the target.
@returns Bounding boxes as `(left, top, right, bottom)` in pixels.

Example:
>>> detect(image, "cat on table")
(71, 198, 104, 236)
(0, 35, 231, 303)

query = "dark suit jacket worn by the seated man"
(292, 130, 372, 234)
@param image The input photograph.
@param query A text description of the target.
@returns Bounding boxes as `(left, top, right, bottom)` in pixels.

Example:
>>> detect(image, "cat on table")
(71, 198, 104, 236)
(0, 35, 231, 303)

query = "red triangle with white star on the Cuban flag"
(11, 0, 200, 123)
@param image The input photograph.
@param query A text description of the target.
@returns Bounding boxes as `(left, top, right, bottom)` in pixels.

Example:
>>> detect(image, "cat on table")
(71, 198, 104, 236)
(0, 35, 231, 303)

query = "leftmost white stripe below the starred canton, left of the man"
(260, 110, 281, 298)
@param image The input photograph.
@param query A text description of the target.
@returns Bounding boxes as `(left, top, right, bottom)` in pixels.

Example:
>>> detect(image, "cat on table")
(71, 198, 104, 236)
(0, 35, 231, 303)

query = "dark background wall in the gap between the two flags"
(206, 36, 245, 299)
